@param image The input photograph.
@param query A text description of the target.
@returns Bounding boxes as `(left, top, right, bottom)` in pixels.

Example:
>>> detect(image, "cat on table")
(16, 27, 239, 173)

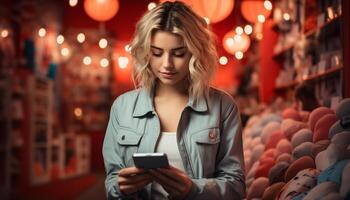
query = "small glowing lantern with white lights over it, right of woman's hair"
(222, 30, 250, 55)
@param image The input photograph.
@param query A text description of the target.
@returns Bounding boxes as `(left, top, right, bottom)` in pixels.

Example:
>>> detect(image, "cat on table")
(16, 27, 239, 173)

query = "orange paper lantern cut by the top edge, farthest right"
(241, 0, 271, 23)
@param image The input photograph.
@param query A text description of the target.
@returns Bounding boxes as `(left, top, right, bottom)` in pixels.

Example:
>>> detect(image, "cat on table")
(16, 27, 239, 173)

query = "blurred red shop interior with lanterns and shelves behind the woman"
(0, 0, 350, 200)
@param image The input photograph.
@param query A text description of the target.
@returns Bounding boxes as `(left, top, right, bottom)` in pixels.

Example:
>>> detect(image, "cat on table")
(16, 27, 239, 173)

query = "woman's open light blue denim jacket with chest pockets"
(103, 88, 245, 200)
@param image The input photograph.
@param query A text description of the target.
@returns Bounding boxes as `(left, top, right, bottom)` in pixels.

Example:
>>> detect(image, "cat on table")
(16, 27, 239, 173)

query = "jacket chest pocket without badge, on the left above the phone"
(117, 128, 142, 167)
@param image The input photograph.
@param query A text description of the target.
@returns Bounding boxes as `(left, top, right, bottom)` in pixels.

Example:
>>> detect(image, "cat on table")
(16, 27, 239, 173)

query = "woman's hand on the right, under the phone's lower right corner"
(149, 166, 193, 199)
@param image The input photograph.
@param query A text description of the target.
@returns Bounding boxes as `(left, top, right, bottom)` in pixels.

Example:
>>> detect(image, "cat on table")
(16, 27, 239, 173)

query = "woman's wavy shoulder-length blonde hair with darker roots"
(130, 1, 217, 100)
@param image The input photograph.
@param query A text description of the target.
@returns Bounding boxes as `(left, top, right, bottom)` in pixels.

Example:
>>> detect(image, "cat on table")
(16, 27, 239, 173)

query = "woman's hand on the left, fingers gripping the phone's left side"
(118, 167, 152, 195)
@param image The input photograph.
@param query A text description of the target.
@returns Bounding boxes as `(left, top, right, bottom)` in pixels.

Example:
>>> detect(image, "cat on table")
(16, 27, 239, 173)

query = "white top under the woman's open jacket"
(152, 132, 185, 200)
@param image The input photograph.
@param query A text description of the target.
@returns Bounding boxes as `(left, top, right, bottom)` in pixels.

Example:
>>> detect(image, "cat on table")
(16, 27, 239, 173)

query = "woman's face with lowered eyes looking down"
(150, 31, 191, 86)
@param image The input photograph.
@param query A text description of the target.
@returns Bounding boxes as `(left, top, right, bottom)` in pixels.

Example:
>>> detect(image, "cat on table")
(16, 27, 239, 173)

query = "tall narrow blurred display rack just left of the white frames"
(27, 76, 53, 185)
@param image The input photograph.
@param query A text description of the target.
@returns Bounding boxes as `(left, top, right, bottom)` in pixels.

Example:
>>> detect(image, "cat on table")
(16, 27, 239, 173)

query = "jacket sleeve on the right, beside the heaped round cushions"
(187, 103, 246, 200)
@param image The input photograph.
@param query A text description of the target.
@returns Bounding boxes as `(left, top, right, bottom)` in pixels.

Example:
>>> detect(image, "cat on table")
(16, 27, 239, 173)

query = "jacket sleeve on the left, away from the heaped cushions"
(102, 100, 136, 200)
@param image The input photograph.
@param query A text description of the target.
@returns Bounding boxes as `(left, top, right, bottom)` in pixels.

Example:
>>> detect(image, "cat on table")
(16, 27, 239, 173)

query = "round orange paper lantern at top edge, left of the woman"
(84, 0, 119, 22)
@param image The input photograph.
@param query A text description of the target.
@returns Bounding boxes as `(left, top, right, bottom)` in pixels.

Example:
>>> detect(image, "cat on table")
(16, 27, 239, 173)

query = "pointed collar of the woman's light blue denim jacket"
(133, 88, 208, 117)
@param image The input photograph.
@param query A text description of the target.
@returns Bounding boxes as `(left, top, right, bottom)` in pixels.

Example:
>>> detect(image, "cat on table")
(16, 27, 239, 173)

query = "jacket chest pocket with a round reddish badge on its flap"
(191, 128, 220, 178)
